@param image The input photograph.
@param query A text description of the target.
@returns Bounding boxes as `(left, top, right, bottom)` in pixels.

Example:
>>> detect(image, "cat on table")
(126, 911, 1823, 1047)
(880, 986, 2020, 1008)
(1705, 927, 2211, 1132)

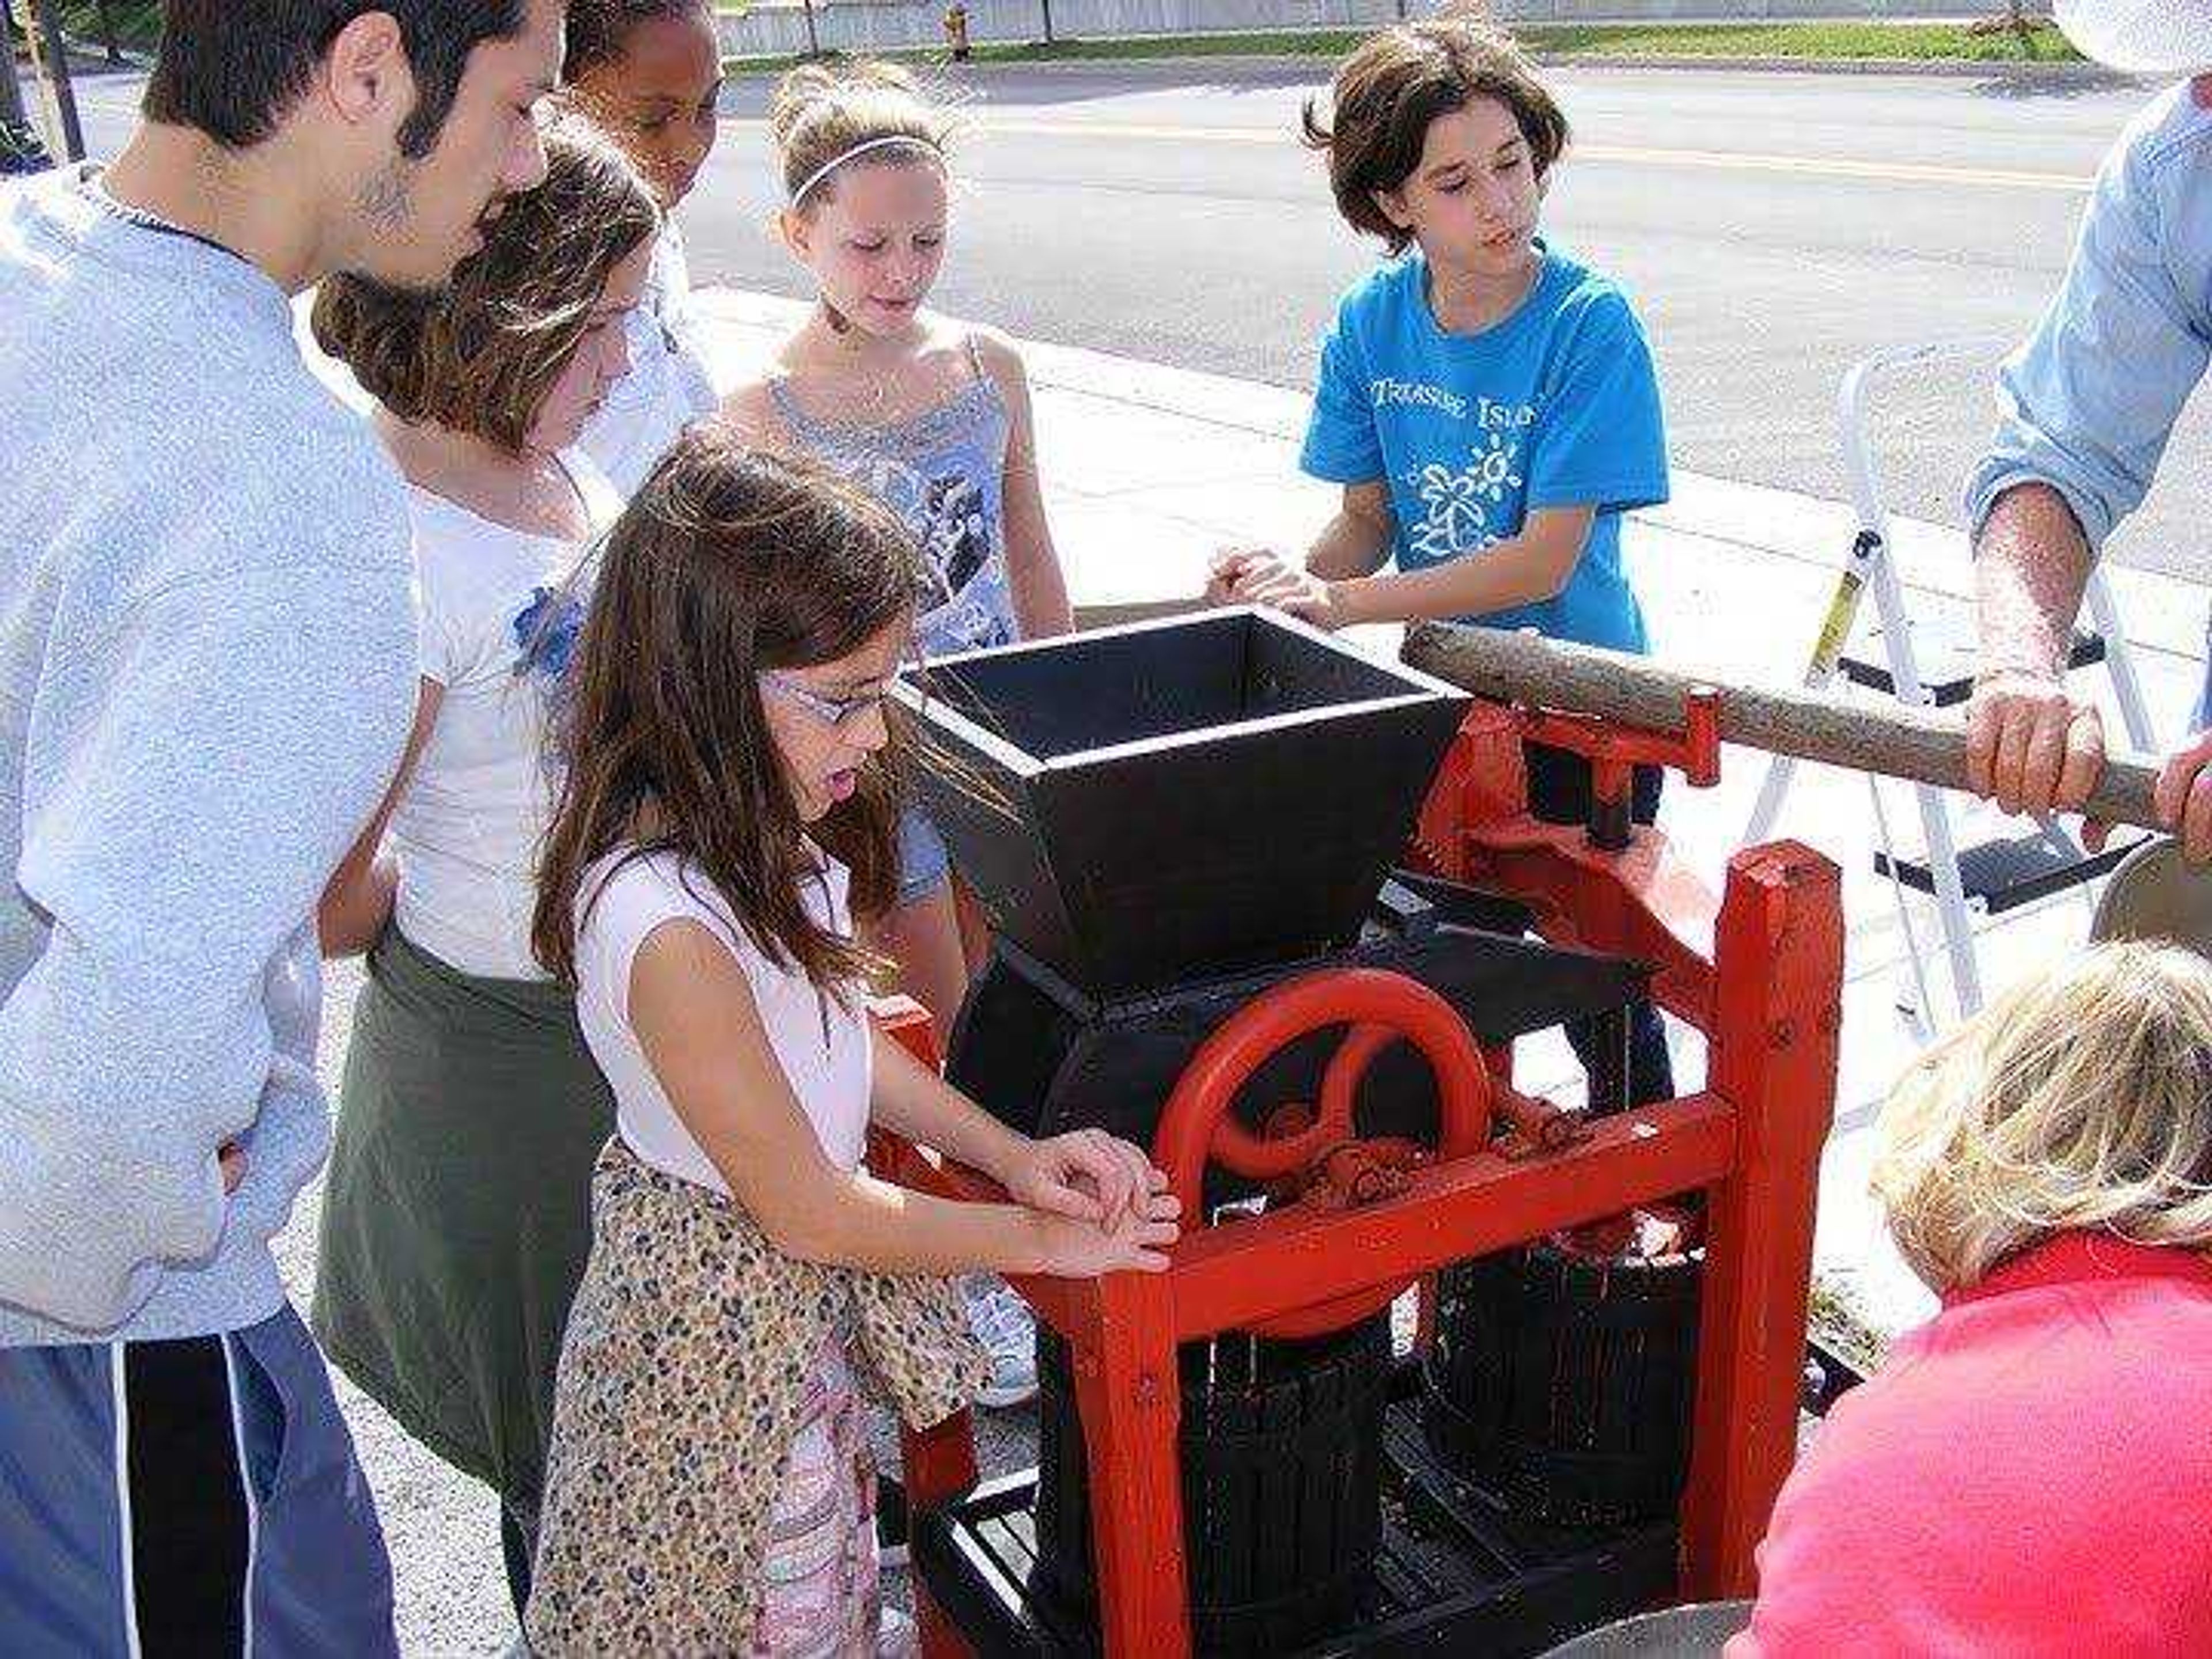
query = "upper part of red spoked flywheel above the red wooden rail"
(1153, 969, 1491, 1225)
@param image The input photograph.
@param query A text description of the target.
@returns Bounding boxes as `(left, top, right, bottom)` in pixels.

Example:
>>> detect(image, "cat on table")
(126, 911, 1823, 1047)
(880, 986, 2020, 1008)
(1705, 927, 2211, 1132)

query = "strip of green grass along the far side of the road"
(726, 19, 2081, 75)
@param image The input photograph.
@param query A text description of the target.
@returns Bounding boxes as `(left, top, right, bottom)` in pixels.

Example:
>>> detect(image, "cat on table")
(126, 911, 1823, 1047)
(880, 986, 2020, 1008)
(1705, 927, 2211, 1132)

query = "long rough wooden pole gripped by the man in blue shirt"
(1404, 622, 2165, 830)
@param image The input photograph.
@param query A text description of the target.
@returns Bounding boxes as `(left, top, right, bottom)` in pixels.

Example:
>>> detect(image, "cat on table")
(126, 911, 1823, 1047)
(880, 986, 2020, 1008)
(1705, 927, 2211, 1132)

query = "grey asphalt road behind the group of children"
(685, 64, 2212, 573)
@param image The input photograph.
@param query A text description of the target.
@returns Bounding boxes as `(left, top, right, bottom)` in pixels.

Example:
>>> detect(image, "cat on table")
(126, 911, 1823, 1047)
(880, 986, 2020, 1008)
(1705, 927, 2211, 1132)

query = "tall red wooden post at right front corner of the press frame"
(1681, 843, 1843, 1601)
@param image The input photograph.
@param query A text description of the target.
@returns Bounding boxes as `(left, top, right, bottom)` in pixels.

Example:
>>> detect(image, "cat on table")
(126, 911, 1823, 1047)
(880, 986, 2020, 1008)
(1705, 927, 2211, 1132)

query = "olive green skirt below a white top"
(314, 929, 615, 1528)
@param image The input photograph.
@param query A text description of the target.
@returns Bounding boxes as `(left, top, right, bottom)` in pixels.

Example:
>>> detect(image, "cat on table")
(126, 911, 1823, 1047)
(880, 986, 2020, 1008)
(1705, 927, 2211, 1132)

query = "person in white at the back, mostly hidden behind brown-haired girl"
(562, 0, 721, 498)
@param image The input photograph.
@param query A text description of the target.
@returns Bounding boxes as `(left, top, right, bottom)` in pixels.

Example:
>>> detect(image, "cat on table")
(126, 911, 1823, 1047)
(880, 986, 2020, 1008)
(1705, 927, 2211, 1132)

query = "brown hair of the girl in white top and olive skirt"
(312, 115, 661, 456)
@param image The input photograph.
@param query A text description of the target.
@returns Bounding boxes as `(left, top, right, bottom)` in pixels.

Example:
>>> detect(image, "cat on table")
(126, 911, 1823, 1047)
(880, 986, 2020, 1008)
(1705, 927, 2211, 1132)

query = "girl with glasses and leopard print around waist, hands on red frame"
(527, 435, 1177, 1654)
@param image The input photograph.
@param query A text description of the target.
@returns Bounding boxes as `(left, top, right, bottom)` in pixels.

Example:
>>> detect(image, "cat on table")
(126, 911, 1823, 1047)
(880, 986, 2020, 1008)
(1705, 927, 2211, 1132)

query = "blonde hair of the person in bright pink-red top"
(1873, 940, 2212, 1292)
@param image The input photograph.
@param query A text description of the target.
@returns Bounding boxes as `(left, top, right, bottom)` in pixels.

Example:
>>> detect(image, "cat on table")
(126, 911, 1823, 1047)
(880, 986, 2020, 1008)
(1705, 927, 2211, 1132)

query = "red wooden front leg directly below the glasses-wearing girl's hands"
(1069, 1274, 1190, 1659)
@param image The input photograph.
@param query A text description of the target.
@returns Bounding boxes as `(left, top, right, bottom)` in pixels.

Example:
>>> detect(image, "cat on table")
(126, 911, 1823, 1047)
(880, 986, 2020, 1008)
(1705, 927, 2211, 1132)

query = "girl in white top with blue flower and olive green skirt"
(314, 122, 659, 1608)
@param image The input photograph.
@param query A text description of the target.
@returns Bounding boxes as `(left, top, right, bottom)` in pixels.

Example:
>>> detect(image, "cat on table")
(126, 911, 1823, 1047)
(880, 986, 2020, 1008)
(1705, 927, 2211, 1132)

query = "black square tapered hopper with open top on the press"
(898, 608, 1467, 995)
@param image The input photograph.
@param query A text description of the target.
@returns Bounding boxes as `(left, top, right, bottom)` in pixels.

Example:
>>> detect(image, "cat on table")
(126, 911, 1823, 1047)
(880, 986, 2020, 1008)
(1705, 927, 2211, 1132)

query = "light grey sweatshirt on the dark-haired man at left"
(0, 171, 416, 1347)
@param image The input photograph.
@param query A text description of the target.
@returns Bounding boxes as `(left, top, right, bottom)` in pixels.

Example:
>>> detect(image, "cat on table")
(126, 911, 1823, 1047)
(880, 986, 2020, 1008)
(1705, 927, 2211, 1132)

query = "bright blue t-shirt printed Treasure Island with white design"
(1298, 243, 1668, 650)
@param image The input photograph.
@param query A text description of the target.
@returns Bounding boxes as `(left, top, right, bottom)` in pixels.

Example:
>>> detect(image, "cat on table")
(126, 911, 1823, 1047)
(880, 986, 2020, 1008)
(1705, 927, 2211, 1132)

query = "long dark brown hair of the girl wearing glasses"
(531, 431, 918, 995)
